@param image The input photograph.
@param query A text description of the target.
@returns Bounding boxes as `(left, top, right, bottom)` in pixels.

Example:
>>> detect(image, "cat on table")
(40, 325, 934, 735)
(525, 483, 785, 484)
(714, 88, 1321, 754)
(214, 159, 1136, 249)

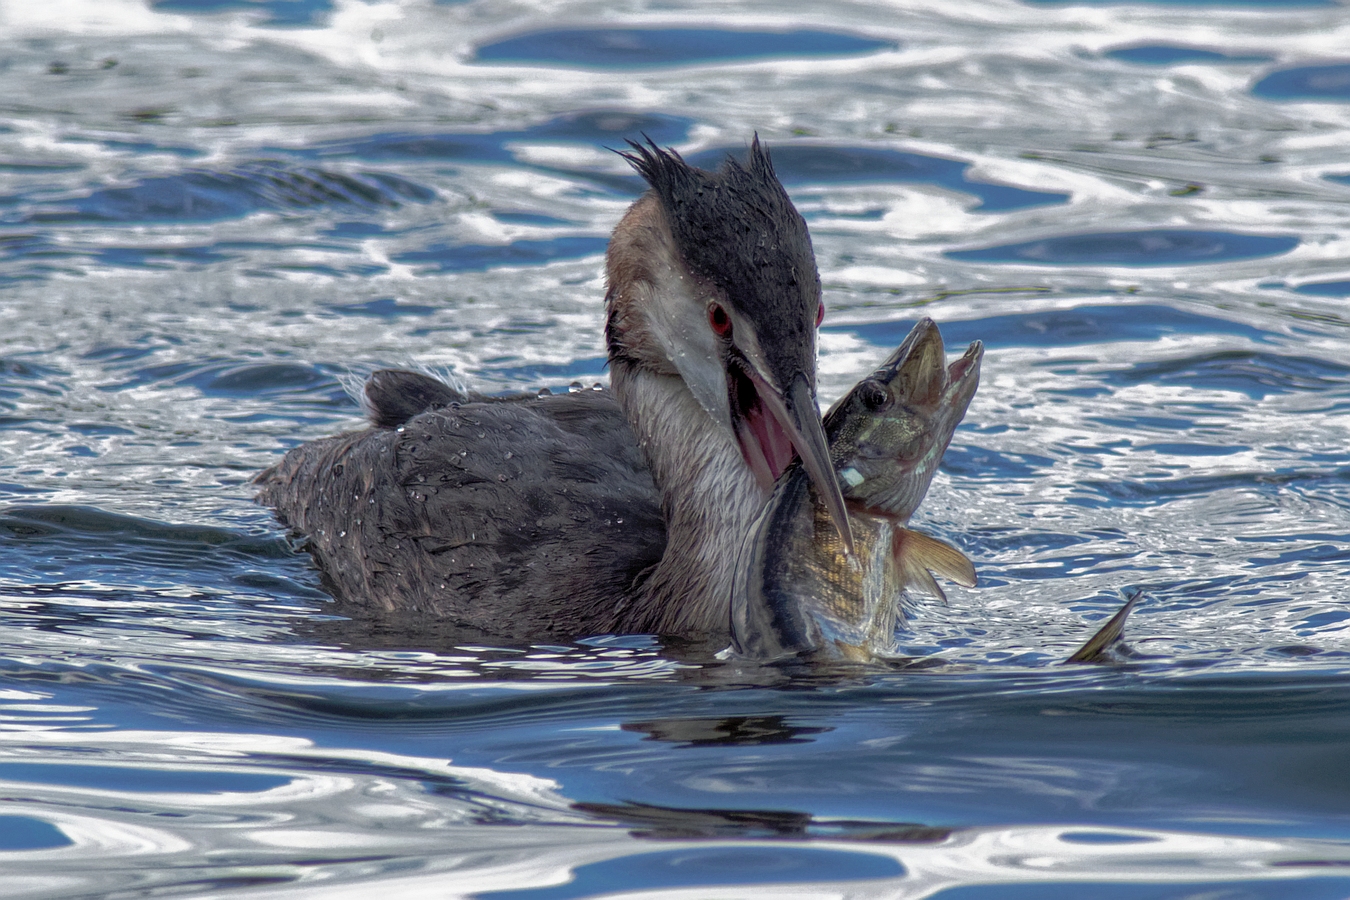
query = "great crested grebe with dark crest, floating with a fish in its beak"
(258, 138, 852, 641)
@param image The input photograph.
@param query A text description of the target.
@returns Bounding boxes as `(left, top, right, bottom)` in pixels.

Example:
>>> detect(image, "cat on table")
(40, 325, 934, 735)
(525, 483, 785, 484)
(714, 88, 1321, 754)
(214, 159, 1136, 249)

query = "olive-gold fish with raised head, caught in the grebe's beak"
(730, 318, 984, 661)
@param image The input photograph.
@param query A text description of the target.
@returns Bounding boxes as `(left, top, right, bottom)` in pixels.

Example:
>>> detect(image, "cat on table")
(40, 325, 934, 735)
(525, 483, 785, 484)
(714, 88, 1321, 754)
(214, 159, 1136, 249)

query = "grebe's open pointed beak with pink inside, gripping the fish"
(736, 366, 853, 556)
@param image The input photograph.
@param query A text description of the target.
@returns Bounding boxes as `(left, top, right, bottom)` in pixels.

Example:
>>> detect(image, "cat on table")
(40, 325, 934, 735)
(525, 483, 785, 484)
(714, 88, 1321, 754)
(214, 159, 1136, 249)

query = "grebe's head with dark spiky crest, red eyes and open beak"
(606, 136, 852, 549)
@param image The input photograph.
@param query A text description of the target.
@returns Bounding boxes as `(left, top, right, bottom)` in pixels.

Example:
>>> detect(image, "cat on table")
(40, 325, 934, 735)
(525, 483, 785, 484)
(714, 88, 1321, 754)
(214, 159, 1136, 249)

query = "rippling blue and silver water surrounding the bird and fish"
(0, 0, 1350, 900)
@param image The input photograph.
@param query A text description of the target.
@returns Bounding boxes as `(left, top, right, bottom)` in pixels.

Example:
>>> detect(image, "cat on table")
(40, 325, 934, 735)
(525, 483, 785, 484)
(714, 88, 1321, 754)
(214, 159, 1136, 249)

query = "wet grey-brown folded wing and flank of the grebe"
(259, 391, 666, 637)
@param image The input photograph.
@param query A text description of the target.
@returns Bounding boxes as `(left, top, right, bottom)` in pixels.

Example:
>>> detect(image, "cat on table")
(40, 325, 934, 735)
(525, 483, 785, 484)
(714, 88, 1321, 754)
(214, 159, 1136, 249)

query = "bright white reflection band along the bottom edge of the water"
(0, 731, 1350, 900)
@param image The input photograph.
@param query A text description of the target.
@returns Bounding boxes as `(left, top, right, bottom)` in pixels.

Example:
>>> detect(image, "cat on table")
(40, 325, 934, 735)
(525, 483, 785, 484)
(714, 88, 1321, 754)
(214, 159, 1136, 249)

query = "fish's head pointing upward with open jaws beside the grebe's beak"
(825, 318, 984, 524)
